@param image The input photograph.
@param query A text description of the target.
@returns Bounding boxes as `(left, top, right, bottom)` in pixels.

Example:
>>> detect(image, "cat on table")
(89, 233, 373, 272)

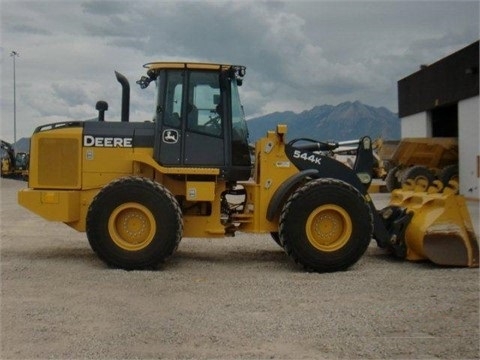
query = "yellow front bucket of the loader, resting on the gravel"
(390, 182, 479, 267)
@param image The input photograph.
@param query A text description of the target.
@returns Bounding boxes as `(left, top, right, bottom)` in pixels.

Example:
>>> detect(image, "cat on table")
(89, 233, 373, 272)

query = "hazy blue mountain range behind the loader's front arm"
(247, 101, 401, 143)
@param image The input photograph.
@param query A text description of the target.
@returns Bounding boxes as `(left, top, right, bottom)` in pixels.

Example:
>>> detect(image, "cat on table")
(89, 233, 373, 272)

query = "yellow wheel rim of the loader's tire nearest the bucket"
(306, 204, 352, 252)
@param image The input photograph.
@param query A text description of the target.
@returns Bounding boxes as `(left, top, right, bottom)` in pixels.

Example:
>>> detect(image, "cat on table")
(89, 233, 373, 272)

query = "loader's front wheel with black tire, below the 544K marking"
(279, 179, 373, 272)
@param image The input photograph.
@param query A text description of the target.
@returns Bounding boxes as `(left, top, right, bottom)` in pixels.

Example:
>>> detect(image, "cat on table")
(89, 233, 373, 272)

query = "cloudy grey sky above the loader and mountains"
(0, 0, 480, 142)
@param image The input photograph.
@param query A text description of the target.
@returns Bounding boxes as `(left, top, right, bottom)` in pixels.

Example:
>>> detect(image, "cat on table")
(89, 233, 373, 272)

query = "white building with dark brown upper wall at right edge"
(398, 41, 480, 199)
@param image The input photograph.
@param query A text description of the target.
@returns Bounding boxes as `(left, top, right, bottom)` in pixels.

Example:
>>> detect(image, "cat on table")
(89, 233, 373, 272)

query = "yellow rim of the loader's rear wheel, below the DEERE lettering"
(108, 202, 157, 251)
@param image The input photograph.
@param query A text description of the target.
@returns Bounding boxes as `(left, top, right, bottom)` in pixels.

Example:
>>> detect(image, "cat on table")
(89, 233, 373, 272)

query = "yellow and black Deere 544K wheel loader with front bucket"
(18, 62, 478, 272)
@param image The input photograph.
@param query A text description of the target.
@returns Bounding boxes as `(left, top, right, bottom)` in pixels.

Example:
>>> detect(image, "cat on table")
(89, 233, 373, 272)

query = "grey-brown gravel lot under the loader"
(1, 179, 480, 359)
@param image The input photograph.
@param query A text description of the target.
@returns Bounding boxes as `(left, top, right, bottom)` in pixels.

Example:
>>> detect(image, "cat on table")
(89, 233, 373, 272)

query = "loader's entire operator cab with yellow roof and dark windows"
(138, 63, 252, 181)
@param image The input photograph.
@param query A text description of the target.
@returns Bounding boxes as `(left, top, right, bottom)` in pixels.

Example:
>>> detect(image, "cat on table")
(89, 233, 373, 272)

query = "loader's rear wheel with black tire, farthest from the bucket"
(86, 177, 183, 270)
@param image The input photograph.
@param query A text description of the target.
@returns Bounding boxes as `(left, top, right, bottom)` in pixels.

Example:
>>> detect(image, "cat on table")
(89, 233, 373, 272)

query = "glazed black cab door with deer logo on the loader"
(154, 70, 226, 167)
